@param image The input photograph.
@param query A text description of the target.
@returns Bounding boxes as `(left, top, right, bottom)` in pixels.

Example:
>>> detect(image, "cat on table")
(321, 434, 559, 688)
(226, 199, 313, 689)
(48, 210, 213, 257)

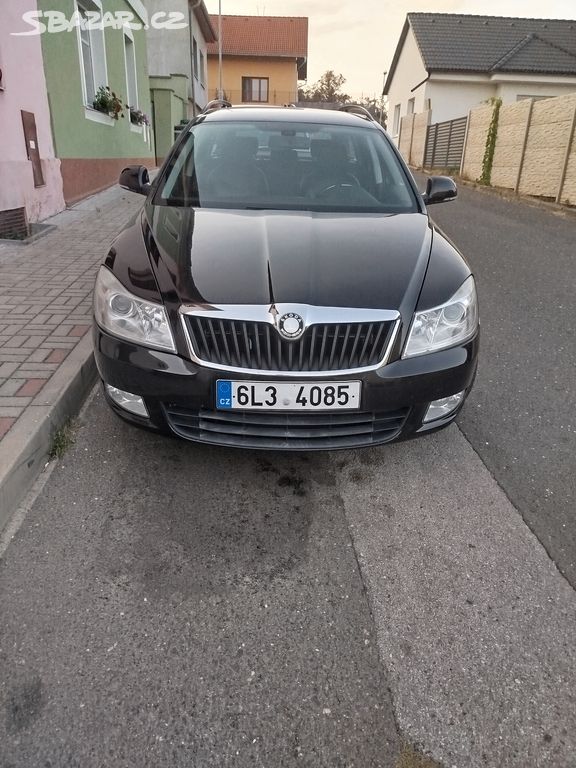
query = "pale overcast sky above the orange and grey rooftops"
(205, 0, 576, 97)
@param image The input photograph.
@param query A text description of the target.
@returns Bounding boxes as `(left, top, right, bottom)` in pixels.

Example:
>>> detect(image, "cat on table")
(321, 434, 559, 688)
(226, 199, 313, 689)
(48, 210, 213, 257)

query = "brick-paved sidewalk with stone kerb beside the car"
(0, 186, 144, 530)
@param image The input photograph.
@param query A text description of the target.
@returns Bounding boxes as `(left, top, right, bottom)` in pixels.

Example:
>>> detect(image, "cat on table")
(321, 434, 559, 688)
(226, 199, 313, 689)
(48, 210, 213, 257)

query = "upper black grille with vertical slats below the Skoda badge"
(186, 315, 394, 372)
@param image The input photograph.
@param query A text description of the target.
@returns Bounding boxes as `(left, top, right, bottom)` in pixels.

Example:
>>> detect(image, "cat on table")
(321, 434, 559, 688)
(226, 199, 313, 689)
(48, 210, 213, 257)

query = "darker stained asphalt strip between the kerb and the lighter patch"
(0, 395, 401, 768)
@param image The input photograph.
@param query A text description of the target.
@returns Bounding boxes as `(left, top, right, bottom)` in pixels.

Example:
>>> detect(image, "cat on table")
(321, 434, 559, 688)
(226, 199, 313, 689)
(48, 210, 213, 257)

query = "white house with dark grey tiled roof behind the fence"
(384, 13, 576, 140)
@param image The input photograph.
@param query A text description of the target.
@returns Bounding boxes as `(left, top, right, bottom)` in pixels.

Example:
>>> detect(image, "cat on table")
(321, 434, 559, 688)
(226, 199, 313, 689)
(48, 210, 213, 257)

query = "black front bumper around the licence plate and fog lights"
(93, 325, 479, 450)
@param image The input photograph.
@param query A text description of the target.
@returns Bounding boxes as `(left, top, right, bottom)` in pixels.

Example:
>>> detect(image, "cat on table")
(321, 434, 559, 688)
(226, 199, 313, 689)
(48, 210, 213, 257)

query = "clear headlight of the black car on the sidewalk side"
(94, 267, 176, 352)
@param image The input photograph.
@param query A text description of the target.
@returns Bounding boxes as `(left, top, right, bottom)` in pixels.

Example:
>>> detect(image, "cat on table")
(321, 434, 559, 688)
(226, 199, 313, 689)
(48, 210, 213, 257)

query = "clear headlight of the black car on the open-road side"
(402, 275, 478, 357)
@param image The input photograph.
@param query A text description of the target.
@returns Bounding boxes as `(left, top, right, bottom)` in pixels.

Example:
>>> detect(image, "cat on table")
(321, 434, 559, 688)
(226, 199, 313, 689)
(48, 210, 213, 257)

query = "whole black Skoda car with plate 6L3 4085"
(94, 102, 479, 450)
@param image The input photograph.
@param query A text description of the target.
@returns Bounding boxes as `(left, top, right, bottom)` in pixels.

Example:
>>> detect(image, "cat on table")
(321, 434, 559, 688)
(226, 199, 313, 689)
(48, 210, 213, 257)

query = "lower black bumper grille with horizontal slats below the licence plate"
(164, 404, 409, 451)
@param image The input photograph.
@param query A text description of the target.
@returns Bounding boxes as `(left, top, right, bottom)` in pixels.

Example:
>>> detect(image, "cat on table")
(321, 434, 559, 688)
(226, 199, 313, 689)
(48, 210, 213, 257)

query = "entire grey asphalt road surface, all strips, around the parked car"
(0, 183, 576, 768)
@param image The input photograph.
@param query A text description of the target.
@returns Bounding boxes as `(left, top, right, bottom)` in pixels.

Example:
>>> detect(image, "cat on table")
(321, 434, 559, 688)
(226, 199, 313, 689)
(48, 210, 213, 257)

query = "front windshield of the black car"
(153, 120, 418, 213)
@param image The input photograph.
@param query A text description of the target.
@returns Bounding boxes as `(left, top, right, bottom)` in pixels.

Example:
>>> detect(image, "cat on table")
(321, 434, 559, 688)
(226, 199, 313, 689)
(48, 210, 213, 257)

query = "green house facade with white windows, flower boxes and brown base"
(37, 0, 154, 203)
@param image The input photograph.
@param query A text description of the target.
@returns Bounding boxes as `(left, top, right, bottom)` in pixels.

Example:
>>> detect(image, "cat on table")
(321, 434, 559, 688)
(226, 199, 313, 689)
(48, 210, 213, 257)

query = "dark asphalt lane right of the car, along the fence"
(418, 176, 576, 587)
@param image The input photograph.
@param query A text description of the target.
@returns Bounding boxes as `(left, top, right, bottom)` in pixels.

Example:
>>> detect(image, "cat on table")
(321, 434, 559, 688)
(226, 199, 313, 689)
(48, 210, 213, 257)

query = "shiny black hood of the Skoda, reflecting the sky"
(145, 205, 432, 313)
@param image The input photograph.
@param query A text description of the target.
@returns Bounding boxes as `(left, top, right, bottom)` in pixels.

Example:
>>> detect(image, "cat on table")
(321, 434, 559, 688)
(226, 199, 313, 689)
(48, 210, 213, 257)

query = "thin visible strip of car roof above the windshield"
(194, 104, 380, 129)
